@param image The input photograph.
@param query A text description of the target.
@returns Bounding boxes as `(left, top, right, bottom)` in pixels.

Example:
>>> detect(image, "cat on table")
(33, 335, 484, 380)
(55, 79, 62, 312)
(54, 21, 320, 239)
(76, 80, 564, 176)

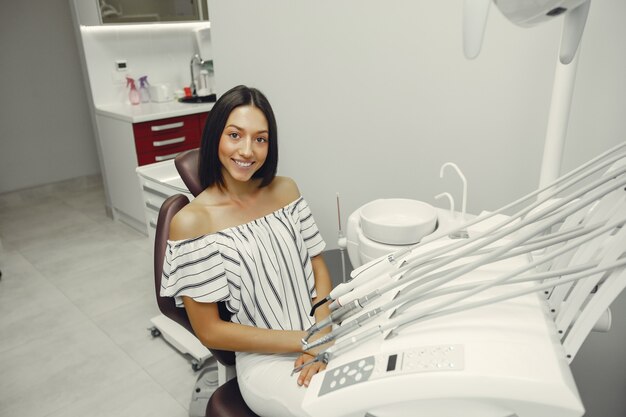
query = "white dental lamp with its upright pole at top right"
(463, 0, 591, 188)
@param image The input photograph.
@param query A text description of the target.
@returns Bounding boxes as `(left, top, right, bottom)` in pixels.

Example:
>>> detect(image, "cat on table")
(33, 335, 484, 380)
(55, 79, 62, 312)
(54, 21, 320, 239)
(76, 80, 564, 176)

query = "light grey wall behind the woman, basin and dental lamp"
(209, 0, 626, 417)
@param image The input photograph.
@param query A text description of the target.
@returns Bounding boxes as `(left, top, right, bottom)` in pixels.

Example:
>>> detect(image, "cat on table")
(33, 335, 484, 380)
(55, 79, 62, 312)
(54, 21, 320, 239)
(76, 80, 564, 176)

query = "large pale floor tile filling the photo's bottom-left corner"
(0, 312, 141, 416)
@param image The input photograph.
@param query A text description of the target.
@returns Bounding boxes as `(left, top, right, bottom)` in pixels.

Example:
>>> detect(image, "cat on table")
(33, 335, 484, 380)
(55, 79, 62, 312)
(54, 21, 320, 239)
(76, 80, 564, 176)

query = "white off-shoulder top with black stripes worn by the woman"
(161, 197, 326, 330)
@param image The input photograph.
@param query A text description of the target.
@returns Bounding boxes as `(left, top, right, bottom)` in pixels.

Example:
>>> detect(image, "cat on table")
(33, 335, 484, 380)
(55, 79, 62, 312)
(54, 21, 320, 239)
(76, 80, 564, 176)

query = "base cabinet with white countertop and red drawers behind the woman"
(95, 102, 213, 233)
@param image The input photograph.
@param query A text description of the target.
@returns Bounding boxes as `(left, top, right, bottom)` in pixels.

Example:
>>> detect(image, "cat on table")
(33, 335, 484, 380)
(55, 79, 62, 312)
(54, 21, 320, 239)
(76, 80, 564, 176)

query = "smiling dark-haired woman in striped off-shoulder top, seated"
(161, 86, 331, 417)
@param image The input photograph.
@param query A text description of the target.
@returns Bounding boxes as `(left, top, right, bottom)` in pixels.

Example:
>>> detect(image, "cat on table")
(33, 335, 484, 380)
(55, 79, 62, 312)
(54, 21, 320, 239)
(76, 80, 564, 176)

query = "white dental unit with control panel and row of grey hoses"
(294, 143, 626, 417)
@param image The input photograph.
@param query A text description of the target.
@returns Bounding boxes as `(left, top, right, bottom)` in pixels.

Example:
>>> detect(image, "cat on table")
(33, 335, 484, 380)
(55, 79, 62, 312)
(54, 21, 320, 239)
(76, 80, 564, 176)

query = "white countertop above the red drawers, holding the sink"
(96, 101, 215, 123)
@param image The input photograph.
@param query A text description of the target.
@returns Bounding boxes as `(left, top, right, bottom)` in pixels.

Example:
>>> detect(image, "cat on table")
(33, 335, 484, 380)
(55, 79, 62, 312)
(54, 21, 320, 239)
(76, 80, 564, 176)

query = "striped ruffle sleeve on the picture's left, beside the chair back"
(160, 236, 230, 307)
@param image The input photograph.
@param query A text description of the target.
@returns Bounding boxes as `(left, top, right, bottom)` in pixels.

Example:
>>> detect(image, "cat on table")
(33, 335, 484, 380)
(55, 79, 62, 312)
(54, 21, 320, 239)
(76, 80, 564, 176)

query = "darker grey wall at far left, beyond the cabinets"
(0, 0, 100, 193)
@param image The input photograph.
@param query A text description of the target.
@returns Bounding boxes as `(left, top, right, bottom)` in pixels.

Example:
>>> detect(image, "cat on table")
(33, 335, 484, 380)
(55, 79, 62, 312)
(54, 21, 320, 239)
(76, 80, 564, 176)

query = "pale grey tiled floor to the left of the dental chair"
(0, 177, 196, 417)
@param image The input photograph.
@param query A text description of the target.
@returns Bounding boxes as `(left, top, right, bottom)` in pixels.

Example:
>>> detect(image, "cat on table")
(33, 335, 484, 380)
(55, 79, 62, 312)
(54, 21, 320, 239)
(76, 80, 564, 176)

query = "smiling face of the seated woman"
(218, 105, 269, 182)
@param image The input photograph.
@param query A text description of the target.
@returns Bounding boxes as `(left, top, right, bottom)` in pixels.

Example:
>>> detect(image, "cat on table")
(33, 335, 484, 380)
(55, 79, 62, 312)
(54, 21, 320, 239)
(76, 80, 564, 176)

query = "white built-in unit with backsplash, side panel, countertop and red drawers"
(70, 11, 213, 234)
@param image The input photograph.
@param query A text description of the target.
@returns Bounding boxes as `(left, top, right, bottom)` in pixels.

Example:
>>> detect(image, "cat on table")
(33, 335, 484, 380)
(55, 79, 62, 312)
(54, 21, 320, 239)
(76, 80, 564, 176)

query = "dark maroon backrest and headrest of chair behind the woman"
(154, 155, 235, 365)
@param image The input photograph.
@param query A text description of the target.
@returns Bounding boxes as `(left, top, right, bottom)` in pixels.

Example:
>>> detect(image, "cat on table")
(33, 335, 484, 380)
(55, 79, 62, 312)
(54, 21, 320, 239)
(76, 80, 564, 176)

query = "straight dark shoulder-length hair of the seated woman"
(198, 85, 278, 188)
